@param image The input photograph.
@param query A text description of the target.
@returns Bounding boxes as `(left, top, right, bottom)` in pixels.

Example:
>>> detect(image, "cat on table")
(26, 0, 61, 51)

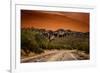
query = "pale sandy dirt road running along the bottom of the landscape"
(21, 50, 89, 63)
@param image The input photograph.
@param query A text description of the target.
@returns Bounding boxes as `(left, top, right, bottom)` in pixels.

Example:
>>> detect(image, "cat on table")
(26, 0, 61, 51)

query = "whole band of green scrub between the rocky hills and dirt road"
(21, 29, 89, 54)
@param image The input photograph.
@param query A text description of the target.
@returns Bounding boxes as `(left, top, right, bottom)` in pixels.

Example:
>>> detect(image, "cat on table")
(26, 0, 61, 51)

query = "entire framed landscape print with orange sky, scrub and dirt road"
(21, 10, 90, 63)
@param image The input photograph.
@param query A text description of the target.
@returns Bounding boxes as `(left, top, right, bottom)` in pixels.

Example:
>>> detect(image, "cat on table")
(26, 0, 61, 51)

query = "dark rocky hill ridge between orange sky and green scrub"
(23, 28, 89, 37)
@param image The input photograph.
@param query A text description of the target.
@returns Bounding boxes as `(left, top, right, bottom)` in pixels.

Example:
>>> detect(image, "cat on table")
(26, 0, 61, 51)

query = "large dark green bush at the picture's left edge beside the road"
(21, 30, 43, 53)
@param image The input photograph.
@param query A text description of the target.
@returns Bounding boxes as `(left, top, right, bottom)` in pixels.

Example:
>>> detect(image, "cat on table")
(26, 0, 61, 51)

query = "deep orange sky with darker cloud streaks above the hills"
(21, 10, 89, 32)
